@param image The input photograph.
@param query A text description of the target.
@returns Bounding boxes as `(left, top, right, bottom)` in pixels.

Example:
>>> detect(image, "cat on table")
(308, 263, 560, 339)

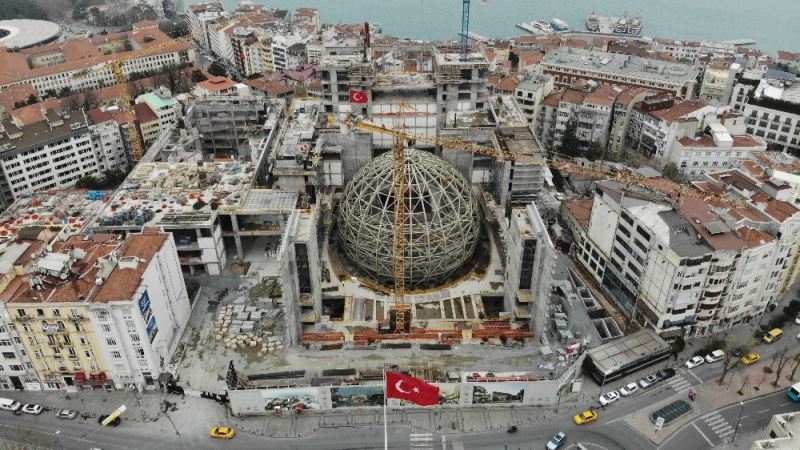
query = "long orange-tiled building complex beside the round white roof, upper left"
(0, 21, 195, 96)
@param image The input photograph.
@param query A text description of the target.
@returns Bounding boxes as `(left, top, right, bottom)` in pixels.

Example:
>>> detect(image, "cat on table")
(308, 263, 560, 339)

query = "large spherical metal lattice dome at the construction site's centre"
(338, 149, 480, 288)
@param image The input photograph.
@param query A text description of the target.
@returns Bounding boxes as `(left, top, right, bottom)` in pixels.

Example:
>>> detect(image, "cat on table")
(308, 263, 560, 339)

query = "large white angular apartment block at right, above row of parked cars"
(577, 178, 800, 338)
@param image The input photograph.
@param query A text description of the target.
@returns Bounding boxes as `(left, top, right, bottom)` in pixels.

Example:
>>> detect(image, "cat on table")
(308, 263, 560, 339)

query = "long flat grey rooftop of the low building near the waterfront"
(542, 47, 697, 86)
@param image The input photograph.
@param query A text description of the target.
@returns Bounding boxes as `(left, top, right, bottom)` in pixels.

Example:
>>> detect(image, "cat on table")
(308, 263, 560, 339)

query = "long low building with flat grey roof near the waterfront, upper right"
(540, 47, 698, 98)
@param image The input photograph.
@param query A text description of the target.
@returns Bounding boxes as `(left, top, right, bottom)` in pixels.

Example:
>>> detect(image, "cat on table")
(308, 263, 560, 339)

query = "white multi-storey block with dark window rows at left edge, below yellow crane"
(0, 104, 127, 206)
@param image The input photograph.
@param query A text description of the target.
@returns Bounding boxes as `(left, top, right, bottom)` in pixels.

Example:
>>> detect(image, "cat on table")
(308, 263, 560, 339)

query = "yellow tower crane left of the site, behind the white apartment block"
(73, 13, 257, 161)
